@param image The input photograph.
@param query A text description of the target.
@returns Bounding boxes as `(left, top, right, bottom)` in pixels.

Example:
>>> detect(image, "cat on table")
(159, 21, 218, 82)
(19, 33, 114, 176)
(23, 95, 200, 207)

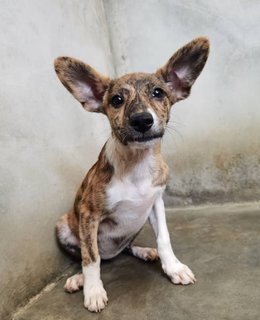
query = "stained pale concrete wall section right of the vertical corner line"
(105, 0, 260, 205)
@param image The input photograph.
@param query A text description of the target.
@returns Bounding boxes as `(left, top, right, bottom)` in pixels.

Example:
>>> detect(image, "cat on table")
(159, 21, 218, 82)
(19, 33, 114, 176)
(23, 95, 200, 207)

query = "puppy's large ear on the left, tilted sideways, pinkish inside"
(54, 57, 110, 112)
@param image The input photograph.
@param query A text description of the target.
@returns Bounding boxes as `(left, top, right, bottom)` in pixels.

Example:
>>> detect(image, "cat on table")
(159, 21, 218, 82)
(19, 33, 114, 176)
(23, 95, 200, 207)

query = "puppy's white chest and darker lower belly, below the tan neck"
(98, 177, 161, 259)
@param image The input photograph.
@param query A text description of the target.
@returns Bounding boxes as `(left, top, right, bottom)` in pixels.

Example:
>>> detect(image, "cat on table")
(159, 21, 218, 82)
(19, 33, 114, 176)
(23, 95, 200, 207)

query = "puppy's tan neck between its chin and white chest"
(105, 135, 161, 178)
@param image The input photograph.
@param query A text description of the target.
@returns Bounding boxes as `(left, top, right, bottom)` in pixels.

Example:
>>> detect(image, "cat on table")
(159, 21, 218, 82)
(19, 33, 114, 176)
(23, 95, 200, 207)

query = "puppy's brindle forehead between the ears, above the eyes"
(108, 73, 164, 93)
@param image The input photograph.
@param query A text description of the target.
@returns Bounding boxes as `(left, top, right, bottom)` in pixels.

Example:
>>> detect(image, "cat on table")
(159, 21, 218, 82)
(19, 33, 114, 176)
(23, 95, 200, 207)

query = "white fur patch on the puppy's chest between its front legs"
(107, 154, 162, 236)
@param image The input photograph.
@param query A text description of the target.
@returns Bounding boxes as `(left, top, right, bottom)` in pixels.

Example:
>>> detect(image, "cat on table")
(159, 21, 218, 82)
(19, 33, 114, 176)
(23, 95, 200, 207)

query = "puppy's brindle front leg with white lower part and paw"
(80, 212, 108, 312)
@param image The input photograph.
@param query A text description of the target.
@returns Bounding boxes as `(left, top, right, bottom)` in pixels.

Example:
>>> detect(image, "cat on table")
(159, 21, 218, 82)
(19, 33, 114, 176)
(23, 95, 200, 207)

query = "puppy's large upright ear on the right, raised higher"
(156, 37, 209, 101)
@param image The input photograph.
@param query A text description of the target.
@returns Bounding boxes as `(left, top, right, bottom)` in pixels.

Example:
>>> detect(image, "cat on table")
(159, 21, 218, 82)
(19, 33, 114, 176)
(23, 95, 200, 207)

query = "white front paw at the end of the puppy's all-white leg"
(162, 262, 196, 285)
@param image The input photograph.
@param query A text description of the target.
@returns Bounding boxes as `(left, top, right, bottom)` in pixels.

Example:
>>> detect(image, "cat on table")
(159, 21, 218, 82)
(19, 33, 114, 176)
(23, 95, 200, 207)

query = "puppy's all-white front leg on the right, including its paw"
(149, 195, 196, 285)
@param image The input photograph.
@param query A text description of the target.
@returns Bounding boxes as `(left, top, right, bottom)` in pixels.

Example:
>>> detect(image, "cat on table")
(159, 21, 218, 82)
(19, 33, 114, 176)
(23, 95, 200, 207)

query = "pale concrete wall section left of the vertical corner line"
(0, 0, 113, 319)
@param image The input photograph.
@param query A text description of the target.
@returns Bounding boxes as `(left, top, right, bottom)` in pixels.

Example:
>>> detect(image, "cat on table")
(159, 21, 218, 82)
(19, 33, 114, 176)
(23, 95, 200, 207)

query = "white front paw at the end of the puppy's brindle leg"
(84, 281, 108, 312)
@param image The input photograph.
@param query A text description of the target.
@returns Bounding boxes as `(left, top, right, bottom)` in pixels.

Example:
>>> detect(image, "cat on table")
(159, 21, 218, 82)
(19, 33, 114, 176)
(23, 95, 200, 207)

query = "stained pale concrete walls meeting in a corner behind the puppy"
(0, 0, 260, 319)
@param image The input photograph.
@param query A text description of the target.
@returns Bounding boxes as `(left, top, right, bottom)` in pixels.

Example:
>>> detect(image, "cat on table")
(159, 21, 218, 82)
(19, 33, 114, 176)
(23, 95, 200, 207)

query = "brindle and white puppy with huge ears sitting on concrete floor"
(54, 37, 209, 312)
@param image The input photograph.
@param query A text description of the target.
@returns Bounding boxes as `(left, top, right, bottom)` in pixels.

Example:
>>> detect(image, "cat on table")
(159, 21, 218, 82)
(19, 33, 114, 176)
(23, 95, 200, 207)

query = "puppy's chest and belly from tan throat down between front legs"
(98, 139, 164, 259)
